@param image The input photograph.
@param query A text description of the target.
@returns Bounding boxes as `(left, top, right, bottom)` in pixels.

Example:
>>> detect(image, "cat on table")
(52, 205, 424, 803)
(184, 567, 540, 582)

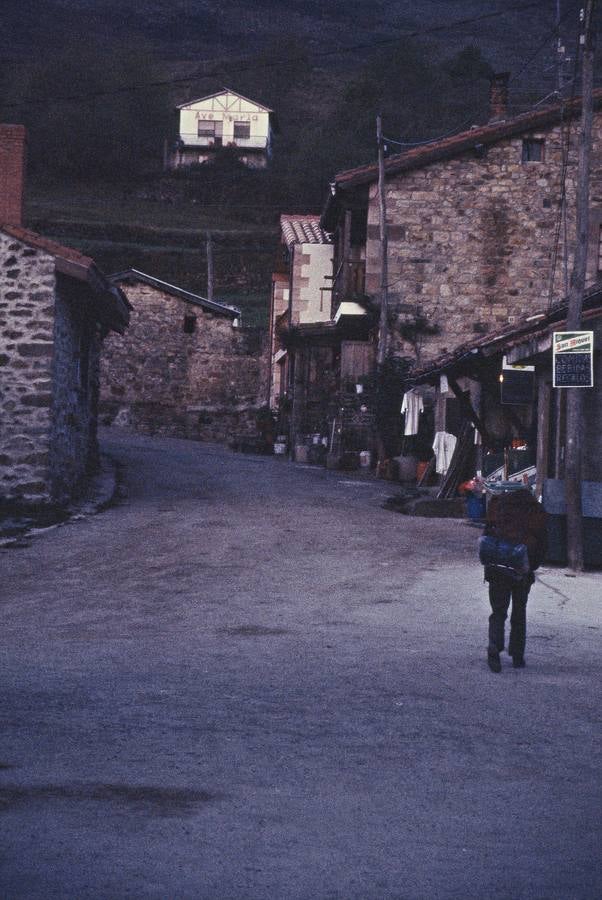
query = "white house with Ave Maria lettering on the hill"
(165, 88, 274, 169)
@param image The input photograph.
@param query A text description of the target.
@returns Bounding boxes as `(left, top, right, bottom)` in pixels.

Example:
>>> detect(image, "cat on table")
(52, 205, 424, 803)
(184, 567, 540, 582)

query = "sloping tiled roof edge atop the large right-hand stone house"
(335, 88, 602, 188)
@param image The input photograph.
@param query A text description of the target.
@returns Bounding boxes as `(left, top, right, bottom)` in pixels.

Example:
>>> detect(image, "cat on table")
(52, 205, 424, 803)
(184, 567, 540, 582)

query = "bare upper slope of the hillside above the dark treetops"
(0, 0, 568, 70)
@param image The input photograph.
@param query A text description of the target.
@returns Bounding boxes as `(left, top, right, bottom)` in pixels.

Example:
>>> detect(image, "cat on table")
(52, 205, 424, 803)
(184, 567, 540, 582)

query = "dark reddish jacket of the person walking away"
(485, 488, 547, 571)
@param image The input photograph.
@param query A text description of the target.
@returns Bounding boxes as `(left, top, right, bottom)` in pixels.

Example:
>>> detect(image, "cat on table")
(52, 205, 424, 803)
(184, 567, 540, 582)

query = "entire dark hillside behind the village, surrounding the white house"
(0, 0, 592, 320)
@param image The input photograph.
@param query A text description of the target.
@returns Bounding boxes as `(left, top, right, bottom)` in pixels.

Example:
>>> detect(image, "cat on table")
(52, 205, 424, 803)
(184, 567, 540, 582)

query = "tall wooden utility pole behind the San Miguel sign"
(564, 0, 595, 572)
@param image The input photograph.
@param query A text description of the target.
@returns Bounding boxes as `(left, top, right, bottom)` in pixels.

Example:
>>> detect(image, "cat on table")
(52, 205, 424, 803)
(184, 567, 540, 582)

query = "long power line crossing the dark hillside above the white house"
(3, 0, 541, 109)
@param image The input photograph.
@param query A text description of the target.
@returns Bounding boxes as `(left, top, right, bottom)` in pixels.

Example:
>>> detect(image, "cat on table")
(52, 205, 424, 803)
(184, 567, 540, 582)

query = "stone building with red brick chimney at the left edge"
(0, 125, 129, 506)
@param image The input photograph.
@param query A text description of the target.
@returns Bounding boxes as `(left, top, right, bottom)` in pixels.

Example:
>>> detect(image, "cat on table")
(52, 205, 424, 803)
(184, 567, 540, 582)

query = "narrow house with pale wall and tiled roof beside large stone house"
(270, 215, 374, 459)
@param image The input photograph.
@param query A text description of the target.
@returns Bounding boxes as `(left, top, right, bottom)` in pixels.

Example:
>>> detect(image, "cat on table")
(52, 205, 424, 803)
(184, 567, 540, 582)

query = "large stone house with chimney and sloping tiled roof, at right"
(321, 77, 602, 365)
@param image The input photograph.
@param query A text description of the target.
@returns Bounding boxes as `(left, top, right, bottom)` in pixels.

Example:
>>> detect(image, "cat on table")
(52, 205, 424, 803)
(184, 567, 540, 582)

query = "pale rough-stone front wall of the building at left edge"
(0, 231, 55, 504)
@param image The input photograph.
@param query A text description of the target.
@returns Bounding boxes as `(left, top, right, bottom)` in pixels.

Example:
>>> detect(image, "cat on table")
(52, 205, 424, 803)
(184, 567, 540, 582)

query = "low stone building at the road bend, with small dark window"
(101, 269, 267, 441)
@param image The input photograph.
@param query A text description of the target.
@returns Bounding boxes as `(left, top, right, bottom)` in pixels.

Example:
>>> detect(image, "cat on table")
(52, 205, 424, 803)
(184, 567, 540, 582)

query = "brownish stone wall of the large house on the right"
(366, 114, 602, 362)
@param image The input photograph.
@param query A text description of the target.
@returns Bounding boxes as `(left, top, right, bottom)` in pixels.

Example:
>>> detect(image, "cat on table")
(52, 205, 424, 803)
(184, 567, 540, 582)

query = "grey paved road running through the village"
(0, 434, 602, 900)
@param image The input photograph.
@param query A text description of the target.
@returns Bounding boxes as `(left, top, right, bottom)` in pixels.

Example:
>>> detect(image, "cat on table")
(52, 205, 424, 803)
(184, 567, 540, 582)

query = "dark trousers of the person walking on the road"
(489, 575, 533, 659)
